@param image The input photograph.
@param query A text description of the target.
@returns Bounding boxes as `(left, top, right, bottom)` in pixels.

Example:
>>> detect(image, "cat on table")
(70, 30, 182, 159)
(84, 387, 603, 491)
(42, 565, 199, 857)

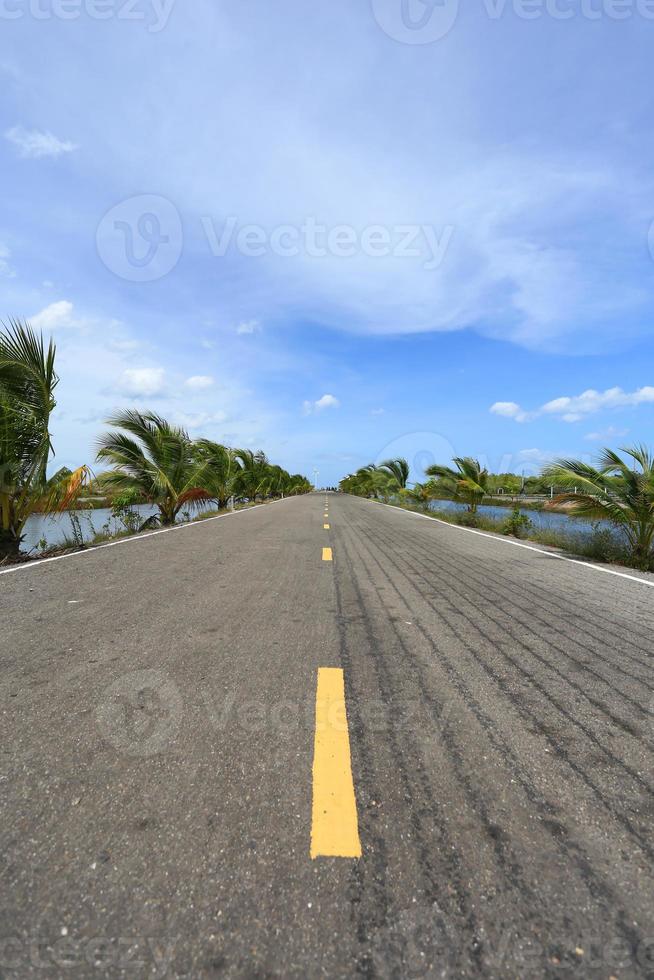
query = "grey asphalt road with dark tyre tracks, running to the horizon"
(0, 494, 654, 980)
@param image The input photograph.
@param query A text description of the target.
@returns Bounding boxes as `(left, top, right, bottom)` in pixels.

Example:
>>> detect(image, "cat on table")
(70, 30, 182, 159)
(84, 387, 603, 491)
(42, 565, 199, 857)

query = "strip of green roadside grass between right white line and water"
(391, 501, 654, 571)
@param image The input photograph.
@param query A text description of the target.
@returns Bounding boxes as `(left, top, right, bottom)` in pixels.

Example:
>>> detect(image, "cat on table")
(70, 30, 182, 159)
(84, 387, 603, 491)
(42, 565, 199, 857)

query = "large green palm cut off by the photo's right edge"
(543, 446, 654, 570)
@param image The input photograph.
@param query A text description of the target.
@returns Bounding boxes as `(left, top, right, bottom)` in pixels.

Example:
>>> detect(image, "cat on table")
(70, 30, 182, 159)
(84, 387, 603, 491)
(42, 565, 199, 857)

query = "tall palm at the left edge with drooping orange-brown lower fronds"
(0, 320, 89, 559)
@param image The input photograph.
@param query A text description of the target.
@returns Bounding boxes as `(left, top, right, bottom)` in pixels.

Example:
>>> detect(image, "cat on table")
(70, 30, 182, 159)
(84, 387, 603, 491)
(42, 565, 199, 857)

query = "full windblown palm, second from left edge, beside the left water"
(98, 409, 216, 525)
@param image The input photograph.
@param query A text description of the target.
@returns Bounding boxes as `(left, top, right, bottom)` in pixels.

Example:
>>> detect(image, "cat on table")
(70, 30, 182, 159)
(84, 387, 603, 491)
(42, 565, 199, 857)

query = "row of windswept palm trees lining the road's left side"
(0, 320, 313, 560)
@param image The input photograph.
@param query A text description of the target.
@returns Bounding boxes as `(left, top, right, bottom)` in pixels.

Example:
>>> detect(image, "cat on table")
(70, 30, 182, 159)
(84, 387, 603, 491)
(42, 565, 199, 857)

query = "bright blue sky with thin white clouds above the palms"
(0, 0, 654, 483)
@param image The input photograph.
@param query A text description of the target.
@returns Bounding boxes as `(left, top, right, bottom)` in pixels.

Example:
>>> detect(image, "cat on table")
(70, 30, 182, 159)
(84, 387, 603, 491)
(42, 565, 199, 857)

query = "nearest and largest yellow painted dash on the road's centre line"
(311, 667, 361, 858)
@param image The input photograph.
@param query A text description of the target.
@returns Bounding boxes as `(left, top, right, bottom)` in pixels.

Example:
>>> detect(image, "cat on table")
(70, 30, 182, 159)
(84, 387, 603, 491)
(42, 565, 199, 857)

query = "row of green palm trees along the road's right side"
(340, 446, 654, 569)
